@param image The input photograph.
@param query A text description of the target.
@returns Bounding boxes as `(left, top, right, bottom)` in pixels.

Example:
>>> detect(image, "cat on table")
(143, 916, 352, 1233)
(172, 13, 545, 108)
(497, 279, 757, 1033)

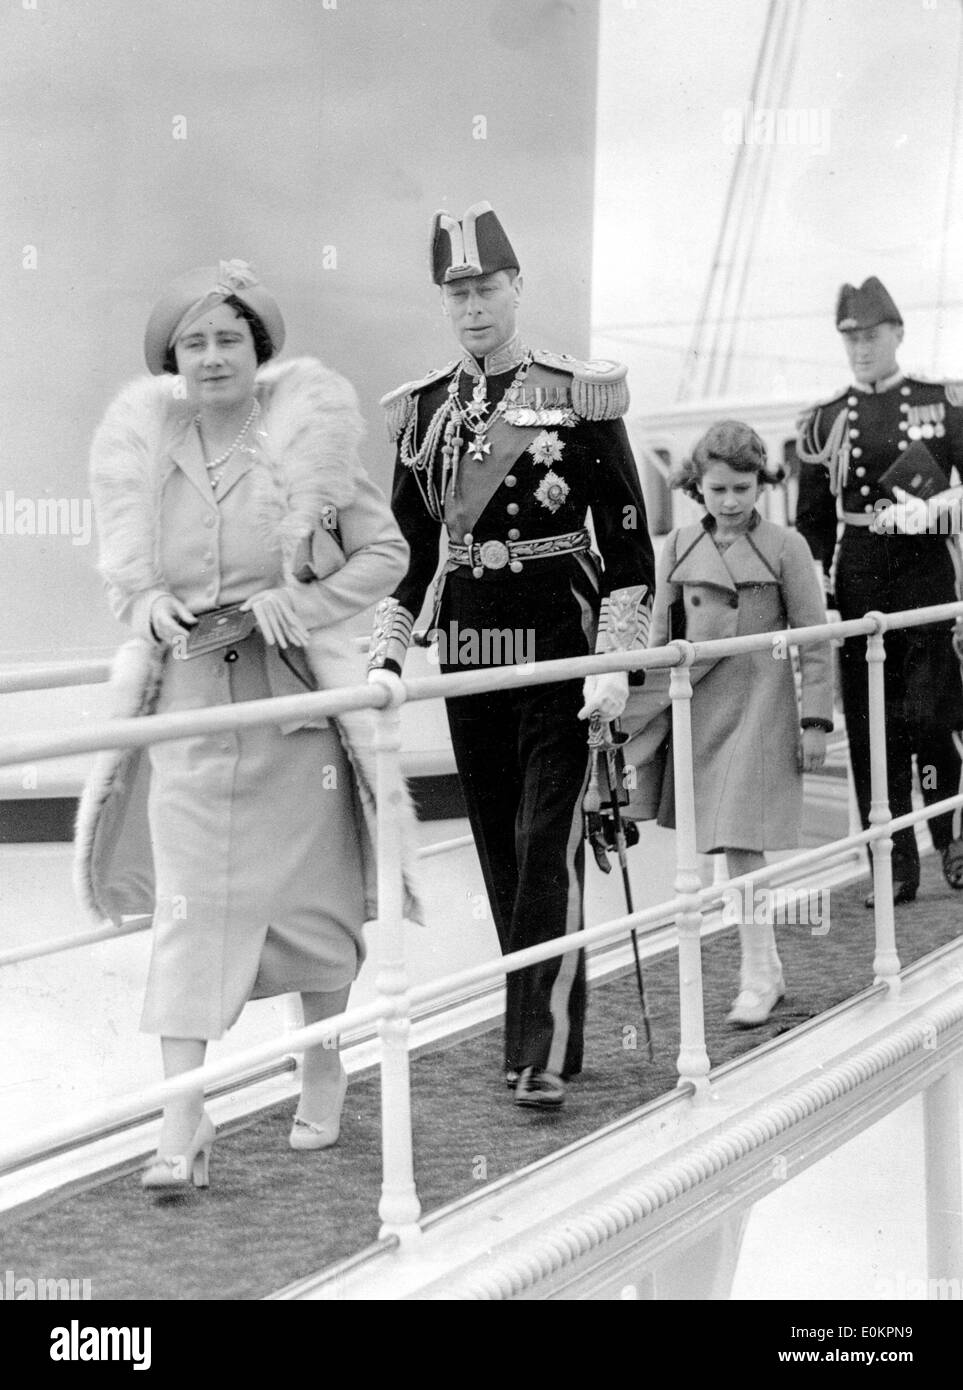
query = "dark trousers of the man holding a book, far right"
(837, 530, 963, 883)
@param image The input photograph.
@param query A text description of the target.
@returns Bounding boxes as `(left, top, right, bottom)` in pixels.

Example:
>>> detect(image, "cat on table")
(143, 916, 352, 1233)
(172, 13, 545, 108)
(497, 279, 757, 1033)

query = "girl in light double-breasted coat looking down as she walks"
(625, 421, 832, 1027)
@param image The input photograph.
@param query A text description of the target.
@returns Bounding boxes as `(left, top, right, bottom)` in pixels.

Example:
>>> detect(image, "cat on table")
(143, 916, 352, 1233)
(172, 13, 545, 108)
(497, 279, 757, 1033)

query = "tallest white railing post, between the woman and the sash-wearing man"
(374, 683, 421, 1240)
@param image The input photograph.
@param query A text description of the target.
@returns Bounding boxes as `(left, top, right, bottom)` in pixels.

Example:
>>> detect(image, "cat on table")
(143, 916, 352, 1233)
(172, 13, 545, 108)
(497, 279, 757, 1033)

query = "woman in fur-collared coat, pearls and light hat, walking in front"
(78, 261, 407, 1188)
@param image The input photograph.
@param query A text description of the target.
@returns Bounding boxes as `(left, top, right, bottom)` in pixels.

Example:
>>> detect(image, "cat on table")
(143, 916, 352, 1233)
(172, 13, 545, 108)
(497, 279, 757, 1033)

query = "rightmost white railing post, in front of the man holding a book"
(866, 613, 899, 994)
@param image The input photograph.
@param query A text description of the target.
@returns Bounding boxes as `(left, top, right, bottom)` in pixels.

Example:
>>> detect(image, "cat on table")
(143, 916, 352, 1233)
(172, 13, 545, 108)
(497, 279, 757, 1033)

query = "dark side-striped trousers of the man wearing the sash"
(441, 574, 591, 1077)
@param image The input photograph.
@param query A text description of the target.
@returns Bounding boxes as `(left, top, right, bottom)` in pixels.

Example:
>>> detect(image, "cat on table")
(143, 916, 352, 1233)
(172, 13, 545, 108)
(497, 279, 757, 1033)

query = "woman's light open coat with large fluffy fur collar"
(75, 359, 420, 922)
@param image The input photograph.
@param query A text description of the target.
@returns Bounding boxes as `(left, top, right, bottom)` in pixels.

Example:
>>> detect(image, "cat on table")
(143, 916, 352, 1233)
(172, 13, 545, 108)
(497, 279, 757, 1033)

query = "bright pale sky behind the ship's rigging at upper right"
(593, 0, 963, 409)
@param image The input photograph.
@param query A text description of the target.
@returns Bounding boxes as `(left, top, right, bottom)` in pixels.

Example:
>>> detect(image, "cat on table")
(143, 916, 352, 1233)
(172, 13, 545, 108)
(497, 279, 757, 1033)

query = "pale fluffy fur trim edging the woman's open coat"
(82, 359, 421, 923)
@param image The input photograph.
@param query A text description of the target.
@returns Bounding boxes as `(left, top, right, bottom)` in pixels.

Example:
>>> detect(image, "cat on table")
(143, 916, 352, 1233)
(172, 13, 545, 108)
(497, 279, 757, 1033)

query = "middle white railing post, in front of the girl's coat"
(668, 642, 709, 1094)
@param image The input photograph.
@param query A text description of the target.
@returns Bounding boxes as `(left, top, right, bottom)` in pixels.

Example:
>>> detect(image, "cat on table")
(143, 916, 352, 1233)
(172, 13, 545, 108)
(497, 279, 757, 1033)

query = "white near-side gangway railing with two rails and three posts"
(0, 603, 963, 1248)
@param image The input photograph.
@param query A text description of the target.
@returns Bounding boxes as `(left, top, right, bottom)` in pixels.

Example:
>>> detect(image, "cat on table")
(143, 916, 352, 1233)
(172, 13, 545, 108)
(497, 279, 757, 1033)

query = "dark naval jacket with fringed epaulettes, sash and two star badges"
(371, 330, 655, 671)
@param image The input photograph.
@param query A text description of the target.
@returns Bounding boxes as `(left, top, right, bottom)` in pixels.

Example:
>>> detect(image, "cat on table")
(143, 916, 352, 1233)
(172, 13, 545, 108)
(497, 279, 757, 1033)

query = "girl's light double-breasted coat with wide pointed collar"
(624, 514, 832, 853)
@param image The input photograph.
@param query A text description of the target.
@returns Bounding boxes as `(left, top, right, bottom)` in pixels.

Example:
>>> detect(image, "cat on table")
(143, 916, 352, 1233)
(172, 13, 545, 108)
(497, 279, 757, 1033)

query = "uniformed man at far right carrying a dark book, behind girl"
(796, 277, 963, 906)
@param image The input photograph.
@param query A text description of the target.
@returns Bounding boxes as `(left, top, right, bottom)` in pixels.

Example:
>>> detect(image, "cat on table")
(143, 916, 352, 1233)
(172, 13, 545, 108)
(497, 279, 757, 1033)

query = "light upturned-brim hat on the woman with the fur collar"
(143, 260, 285, 377)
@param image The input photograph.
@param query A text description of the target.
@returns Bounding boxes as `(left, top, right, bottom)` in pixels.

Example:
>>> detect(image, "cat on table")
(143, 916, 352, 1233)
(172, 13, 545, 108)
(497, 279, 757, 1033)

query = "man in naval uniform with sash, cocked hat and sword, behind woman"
(371, 203, 655, 1108)
